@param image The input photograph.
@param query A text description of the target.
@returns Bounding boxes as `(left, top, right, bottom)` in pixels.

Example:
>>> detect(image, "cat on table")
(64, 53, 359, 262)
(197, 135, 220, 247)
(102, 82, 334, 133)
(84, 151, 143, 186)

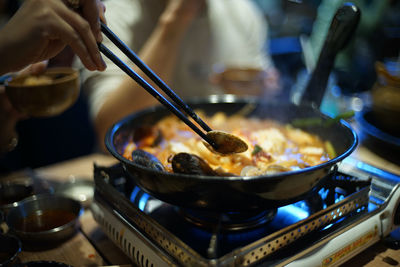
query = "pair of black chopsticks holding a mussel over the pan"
(98, 23, 216, 147)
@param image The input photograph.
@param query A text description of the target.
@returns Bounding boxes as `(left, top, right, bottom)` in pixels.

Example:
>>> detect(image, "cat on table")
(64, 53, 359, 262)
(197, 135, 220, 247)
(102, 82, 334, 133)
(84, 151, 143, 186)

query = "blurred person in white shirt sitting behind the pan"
(76, 0, 278, 152)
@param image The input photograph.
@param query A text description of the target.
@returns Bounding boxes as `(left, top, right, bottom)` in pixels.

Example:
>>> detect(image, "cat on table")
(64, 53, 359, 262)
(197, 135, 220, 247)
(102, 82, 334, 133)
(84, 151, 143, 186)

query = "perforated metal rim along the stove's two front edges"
(93, 164, 369, 267)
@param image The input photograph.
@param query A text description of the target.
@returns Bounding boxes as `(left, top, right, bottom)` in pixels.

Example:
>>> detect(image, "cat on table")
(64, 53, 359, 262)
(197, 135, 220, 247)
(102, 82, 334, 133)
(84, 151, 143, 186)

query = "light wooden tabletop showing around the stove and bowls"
(0, 143, 400, 267)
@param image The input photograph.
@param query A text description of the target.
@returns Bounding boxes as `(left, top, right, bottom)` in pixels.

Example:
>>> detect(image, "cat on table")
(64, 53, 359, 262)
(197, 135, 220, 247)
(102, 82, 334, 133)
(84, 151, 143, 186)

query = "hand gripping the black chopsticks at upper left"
(0, 0, 106, 75)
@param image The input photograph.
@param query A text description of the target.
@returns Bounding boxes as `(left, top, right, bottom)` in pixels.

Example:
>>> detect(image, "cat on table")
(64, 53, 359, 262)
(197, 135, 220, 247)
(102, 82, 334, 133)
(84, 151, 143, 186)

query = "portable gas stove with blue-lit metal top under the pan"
(92, 158, 400, 267)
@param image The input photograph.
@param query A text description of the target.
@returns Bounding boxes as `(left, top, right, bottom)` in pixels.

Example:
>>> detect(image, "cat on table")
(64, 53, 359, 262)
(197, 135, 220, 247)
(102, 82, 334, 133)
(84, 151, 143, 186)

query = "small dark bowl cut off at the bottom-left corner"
(0, 234, 21, 267)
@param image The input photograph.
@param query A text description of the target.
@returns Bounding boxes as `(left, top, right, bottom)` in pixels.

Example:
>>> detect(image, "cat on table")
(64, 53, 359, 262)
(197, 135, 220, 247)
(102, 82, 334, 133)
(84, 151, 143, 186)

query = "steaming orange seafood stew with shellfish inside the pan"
(123, 111, 335, 176)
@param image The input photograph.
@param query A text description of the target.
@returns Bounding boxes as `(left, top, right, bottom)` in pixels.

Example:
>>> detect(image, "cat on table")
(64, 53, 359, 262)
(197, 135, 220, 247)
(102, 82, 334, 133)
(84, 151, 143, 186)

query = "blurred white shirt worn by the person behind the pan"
(76, 0, 271, 118)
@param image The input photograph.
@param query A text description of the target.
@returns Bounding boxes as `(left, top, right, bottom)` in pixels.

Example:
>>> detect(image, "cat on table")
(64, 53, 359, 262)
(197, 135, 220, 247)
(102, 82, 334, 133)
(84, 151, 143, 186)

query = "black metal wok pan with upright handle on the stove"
(105, 4, 360, 212)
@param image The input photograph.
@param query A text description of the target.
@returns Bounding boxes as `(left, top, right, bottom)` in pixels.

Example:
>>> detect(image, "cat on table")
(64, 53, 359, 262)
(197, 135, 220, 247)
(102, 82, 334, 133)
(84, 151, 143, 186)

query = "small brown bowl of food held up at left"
(5, 68, 80, 117)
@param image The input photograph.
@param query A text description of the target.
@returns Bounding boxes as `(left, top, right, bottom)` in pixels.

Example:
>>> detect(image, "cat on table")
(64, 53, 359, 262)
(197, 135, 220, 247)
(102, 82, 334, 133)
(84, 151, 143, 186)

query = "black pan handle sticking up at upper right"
(301, 3, 361, 109)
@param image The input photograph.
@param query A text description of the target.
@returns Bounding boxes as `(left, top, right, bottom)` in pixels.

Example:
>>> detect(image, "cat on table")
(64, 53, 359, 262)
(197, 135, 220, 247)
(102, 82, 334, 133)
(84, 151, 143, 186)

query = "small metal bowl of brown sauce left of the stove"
(6, 194, 82, 244)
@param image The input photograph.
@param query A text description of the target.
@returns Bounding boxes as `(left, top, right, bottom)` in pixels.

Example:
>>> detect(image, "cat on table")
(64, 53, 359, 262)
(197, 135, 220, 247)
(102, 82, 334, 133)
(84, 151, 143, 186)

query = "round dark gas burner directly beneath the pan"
(179, 208, 277, 231)
